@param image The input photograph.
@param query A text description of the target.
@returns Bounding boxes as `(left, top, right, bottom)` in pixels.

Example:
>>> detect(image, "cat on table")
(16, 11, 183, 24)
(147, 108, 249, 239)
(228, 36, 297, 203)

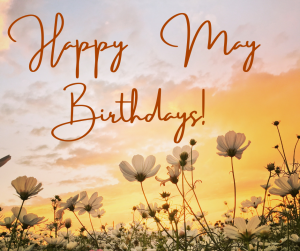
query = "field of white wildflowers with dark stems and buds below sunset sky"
(0, 121, 300, 251)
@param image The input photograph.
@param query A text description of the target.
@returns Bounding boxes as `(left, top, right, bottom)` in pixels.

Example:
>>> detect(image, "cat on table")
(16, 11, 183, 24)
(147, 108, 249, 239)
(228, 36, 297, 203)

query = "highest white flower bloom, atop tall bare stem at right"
(217, 131, 251, 159)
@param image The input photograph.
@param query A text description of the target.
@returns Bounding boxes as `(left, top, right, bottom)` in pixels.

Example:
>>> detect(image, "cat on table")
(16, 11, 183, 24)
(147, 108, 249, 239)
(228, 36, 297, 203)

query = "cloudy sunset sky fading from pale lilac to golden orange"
(0, 0, 300, 231)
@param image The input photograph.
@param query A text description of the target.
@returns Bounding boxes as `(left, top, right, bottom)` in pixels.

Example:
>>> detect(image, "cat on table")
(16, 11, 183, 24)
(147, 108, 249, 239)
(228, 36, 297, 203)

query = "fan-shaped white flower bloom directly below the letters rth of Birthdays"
(119, 155, 160, 182)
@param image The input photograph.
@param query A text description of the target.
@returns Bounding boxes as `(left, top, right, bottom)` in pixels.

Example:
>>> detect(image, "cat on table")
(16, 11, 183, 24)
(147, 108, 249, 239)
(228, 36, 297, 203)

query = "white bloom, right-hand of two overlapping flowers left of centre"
(75, 192, 103, 215)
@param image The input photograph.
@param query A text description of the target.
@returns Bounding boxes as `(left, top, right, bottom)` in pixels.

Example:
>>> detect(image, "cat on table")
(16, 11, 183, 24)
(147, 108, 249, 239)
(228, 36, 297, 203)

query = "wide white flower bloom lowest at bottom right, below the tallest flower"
(224, 216, 270, 242)
